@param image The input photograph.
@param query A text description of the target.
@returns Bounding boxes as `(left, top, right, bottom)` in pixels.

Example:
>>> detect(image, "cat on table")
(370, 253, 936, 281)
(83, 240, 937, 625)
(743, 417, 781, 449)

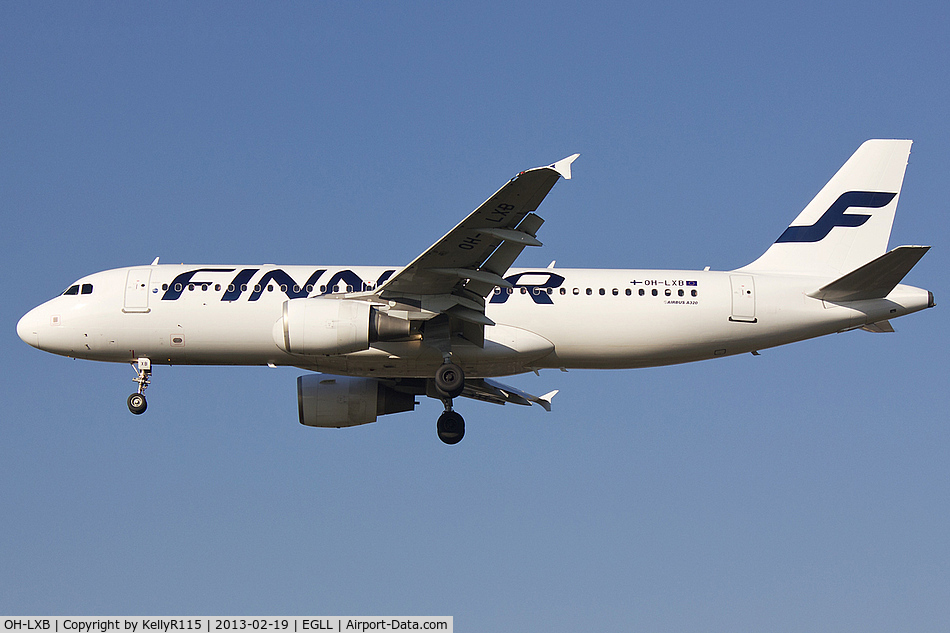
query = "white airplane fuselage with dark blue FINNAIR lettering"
(17, 265, 932, 377)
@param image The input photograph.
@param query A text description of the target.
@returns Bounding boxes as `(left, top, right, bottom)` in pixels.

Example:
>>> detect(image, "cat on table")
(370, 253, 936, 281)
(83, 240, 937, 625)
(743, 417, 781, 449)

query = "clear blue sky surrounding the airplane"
(0, 1, 950, 632)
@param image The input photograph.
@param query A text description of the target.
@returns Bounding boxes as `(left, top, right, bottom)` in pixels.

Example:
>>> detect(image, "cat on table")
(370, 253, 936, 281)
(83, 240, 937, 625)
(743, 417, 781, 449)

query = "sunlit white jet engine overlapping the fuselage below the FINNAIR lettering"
(274, 298, 411, 355)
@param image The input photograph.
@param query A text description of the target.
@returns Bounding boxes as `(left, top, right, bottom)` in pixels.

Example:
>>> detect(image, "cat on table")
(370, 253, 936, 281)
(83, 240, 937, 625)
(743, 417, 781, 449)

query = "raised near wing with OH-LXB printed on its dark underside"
(378, 154, 579, 308)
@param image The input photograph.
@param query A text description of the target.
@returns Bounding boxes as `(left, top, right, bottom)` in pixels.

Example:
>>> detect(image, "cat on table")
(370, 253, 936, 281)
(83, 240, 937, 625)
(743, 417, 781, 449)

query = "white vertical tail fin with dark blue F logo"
(740, 140, 912, 277)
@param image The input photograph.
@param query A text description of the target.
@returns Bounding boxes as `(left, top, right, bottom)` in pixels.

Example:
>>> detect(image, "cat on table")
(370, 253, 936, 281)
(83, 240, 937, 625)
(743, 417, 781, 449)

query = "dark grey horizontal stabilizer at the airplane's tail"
(808, 246, 930, 302)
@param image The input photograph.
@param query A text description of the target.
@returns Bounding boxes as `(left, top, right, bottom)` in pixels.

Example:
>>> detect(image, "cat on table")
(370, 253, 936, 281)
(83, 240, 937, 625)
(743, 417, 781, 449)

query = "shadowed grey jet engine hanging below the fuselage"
(297, 374, 416, 428)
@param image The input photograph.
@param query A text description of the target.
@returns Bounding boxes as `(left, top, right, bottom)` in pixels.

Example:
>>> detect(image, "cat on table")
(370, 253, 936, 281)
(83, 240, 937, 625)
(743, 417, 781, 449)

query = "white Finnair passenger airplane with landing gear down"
(17, 140, 935, 444)
